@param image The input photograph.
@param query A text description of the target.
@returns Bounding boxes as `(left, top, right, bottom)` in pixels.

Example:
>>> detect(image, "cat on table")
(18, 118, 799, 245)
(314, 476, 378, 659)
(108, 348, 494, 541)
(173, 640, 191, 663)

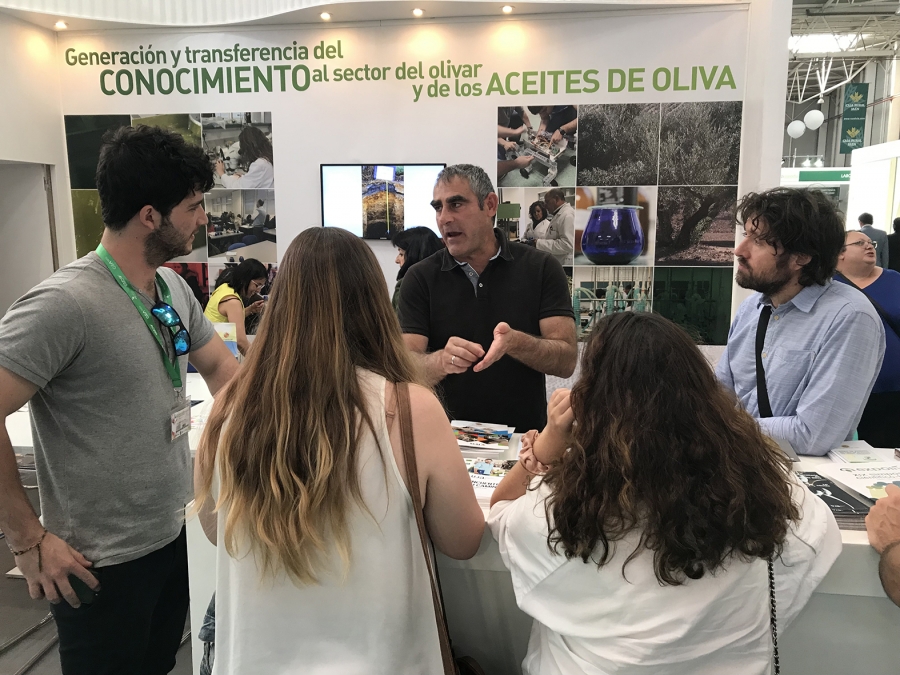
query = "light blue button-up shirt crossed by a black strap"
(716, 280, 884, 455)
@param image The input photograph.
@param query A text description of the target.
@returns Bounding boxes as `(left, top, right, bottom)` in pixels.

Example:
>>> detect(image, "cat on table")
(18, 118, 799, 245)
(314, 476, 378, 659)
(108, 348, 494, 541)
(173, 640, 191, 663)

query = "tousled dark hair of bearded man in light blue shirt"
(737, 187, 844, 286)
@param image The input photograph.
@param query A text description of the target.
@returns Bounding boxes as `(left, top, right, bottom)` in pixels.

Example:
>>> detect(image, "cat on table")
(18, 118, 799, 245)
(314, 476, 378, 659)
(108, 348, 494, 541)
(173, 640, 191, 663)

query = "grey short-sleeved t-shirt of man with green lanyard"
(0, 252, 215, 566)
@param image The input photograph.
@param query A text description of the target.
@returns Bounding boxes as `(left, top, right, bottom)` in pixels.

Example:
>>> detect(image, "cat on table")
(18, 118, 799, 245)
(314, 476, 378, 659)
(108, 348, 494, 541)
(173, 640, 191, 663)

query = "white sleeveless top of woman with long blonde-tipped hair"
(213, 370, 442, 675)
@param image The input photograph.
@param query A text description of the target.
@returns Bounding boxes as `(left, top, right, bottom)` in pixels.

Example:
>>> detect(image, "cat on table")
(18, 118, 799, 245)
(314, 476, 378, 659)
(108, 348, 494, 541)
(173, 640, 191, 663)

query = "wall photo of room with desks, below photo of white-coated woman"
(204, 189, 278, 263)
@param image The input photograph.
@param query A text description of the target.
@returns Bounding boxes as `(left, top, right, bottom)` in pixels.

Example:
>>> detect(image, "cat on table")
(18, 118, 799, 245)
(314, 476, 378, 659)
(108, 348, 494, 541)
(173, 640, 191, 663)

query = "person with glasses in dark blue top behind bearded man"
(834, 230, 900, 448)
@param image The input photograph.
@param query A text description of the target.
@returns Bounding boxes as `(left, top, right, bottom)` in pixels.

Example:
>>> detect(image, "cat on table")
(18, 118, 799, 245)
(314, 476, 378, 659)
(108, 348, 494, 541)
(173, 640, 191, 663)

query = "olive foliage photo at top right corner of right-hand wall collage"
(659, 101, 743, 185)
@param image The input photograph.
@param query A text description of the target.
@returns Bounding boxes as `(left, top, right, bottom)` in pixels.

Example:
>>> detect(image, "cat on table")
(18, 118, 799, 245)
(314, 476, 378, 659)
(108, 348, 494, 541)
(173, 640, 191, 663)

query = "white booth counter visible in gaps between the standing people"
(7, 375, 900, 675)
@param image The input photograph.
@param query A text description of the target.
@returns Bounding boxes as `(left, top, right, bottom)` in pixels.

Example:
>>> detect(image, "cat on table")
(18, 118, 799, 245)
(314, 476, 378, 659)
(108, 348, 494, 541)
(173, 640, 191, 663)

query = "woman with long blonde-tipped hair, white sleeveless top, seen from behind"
(195, 228, 484, 675)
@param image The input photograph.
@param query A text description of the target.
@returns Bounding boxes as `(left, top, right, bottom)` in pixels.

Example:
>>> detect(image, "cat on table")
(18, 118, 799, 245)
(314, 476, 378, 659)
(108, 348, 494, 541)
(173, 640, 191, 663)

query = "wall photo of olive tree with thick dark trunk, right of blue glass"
(656, 185, 737, 267)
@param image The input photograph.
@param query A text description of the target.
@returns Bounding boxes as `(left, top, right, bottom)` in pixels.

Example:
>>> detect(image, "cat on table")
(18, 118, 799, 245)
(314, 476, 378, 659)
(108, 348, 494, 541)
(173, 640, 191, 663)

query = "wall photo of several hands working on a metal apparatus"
(497, 105, 578, 187)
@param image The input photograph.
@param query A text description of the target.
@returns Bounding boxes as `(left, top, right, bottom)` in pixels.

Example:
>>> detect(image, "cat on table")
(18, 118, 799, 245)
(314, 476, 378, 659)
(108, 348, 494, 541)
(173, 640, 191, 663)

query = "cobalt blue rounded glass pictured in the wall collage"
(581, 204, 644, 265)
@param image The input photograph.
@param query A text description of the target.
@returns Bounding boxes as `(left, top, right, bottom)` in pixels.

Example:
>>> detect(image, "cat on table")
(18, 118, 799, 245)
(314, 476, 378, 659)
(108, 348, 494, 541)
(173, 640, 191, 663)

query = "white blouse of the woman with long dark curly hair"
(488, 476, 841, 675)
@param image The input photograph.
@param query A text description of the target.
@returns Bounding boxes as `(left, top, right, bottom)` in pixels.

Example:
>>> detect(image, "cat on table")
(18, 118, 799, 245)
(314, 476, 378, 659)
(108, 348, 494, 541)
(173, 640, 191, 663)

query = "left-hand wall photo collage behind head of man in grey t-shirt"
(65, 112, 278, 320)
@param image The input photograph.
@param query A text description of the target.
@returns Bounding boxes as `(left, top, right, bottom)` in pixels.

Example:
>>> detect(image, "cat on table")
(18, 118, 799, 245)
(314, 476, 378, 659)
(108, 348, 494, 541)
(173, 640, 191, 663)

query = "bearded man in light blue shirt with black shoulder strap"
(716, 188, 885, 455)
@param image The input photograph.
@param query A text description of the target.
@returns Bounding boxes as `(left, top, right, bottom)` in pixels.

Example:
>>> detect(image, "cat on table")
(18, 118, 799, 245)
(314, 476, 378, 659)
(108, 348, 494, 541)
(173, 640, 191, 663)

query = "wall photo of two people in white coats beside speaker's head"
(497, 187, 576, 267)
